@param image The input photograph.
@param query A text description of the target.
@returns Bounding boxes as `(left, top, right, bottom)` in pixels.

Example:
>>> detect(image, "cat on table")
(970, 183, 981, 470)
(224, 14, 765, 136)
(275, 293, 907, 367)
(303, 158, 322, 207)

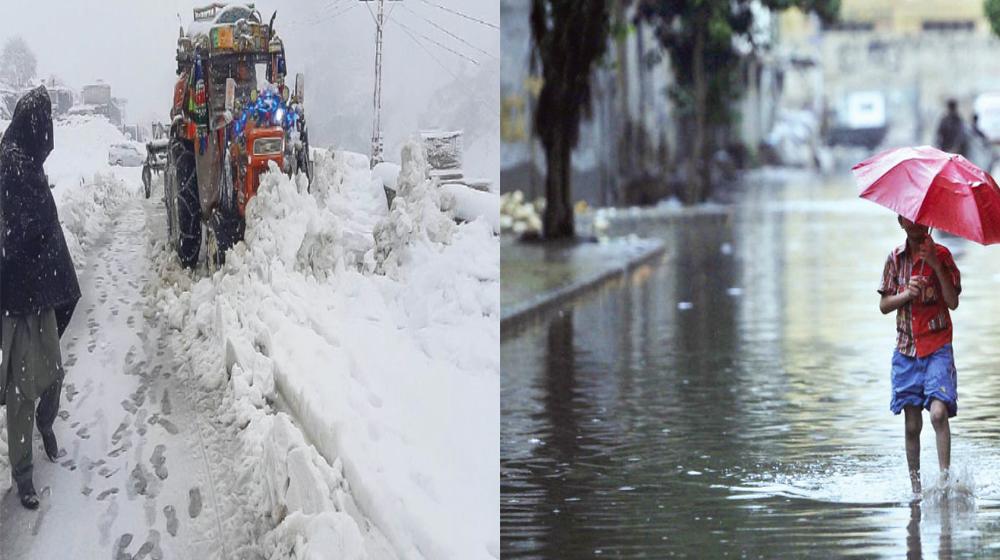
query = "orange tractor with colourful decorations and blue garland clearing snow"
(164, 3, 312, 269)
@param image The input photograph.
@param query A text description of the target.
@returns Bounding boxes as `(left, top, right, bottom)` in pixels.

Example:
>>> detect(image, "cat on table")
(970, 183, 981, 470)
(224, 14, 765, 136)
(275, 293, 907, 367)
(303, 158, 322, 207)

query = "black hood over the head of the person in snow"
(0, 86, 53, 167)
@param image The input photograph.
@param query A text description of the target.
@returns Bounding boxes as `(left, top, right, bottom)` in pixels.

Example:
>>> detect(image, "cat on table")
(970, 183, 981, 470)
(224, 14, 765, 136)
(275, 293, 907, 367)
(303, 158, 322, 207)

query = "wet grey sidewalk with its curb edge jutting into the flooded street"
(500, 236, 664, 330)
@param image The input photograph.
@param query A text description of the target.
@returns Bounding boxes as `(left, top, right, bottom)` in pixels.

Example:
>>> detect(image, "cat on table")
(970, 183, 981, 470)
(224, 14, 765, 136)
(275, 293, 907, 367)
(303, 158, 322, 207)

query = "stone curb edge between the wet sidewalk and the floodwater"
(500, 240, 666, 339)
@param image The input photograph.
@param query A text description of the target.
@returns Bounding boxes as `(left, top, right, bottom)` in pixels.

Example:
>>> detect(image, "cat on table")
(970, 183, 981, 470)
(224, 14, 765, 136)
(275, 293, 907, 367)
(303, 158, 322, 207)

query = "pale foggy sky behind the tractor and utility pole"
(0, 0, 500, 177)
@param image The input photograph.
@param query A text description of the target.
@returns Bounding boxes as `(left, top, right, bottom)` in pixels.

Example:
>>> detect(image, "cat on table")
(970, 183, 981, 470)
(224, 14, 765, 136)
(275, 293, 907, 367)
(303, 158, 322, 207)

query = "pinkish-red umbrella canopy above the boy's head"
(851, 146, 1000, 245)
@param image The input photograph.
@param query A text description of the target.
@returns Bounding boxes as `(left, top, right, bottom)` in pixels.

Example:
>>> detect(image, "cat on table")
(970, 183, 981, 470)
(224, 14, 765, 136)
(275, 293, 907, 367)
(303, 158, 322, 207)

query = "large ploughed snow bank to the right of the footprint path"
(157, 143, 500, 559)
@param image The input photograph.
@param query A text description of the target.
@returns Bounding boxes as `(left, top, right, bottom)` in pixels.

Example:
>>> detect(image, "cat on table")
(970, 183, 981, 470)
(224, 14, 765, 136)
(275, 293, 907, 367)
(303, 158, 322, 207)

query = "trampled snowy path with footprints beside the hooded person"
(0, 194, 260, 558)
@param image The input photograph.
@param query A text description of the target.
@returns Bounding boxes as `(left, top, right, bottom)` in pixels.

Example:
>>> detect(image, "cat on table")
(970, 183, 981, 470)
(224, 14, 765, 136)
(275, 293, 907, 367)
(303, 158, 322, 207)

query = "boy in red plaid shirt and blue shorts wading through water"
(878, 216, 962, 494)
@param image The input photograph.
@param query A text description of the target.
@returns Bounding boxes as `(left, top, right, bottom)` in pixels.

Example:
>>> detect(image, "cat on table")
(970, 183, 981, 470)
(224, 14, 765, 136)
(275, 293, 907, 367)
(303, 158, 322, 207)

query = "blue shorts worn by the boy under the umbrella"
(889, 344, 958, 418)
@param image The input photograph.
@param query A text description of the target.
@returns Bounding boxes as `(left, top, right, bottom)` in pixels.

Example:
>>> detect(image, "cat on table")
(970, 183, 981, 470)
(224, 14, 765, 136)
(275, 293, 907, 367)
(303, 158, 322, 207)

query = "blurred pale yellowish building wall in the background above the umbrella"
(779, 0, 1000, 145)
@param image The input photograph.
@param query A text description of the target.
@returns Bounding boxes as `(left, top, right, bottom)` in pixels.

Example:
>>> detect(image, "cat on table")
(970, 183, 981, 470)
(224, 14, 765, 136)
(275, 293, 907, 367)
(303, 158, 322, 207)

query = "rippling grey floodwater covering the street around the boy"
(500, 168, 1000, 558)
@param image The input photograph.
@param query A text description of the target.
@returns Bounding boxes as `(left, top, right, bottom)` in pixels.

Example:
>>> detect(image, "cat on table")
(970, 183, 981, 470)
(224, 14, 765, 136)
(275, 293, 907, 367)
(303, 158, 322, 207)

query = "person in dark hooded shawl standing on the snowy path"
(0, 86, 80, 509)
